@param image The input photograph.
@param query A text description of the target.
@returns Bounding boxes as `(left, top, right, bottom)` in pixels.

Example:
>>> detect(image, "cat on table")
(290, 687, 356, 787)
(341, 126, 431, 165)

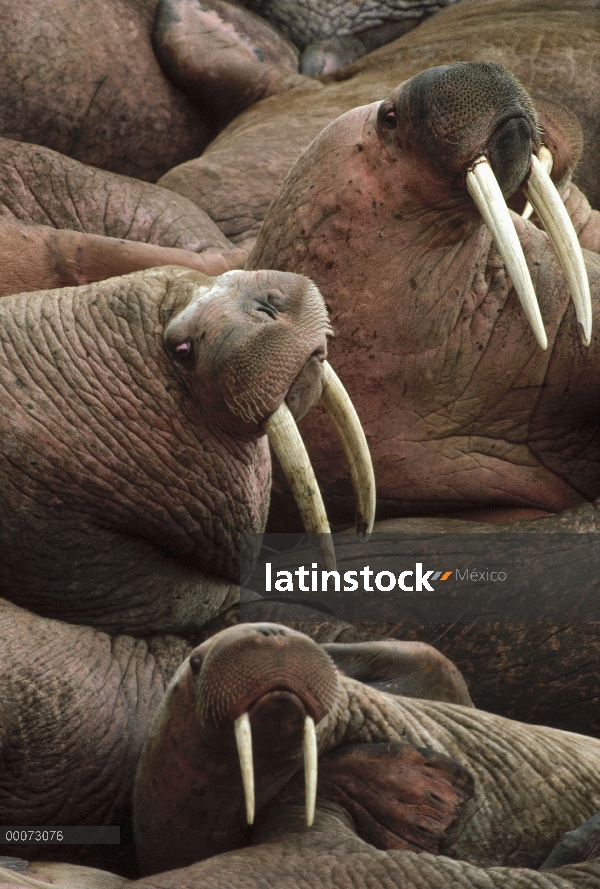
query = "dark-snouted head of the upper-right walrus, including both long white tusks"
(376, 62, 592, 349)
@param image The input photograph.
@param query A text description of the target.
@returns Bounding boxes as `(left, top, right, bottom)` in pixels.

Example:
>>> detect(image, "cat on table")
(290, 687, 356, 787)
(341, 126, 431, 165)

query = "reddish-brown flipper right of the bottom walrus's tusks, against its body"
(318, 742, 474, 854)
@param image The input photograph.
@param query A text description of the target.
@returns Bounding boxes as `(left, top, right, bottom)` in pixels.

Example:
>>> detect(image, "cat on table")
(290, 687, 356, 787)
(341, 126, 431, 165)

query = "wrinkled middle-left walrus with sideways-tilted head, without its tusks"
(0, 267, 329, 634)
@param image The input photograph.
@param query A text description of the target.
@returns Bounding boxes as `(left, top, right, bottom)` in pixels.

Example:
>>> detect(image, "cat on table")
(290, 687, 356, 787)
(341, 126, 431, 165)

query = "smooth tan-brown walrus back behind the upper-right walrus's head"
(160, 0, 600, 243)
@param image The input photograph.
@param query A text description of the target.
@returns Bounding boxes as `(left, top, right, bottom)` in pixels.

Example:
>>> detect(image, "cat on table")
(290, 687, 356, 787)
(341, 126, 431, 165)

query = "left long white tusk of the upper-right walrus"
(467, 157, 548, 350)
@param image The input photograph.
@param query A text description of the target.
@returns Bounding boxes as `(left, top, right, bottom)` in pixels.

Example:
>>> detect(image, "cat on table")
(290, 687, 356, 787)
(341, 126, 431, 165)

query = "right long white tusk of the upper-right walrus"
(524, 155, 592, 346)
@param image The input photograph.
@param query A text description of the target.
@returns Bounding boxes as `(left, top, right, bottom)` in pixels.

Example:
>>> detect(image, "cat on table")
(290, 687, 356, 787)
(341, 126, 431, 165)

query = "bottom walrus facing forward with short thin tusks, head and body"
(134, 624, 600, 886)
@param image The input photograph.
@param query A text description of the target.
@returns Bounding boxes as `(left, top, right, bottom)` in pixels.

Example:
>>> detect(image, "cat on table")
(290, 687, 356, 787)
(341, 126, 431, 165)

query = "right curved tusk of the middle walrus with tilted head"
(321, 361, 375, 542)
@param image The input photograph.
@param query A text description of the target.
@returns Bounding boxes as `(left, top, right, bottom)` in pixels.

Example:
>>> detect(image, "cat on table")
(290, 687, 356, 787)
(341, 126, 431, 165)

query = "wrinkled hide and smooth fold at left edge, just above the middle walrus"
(0, 139, 247, 296)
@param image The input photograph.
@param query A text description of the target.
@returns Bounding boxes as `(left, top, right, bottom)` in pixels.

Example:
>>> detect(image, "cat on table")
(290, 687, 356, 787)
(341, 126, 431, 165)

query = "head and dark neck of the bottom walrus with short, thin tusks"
(134, 624, 340, 871)
